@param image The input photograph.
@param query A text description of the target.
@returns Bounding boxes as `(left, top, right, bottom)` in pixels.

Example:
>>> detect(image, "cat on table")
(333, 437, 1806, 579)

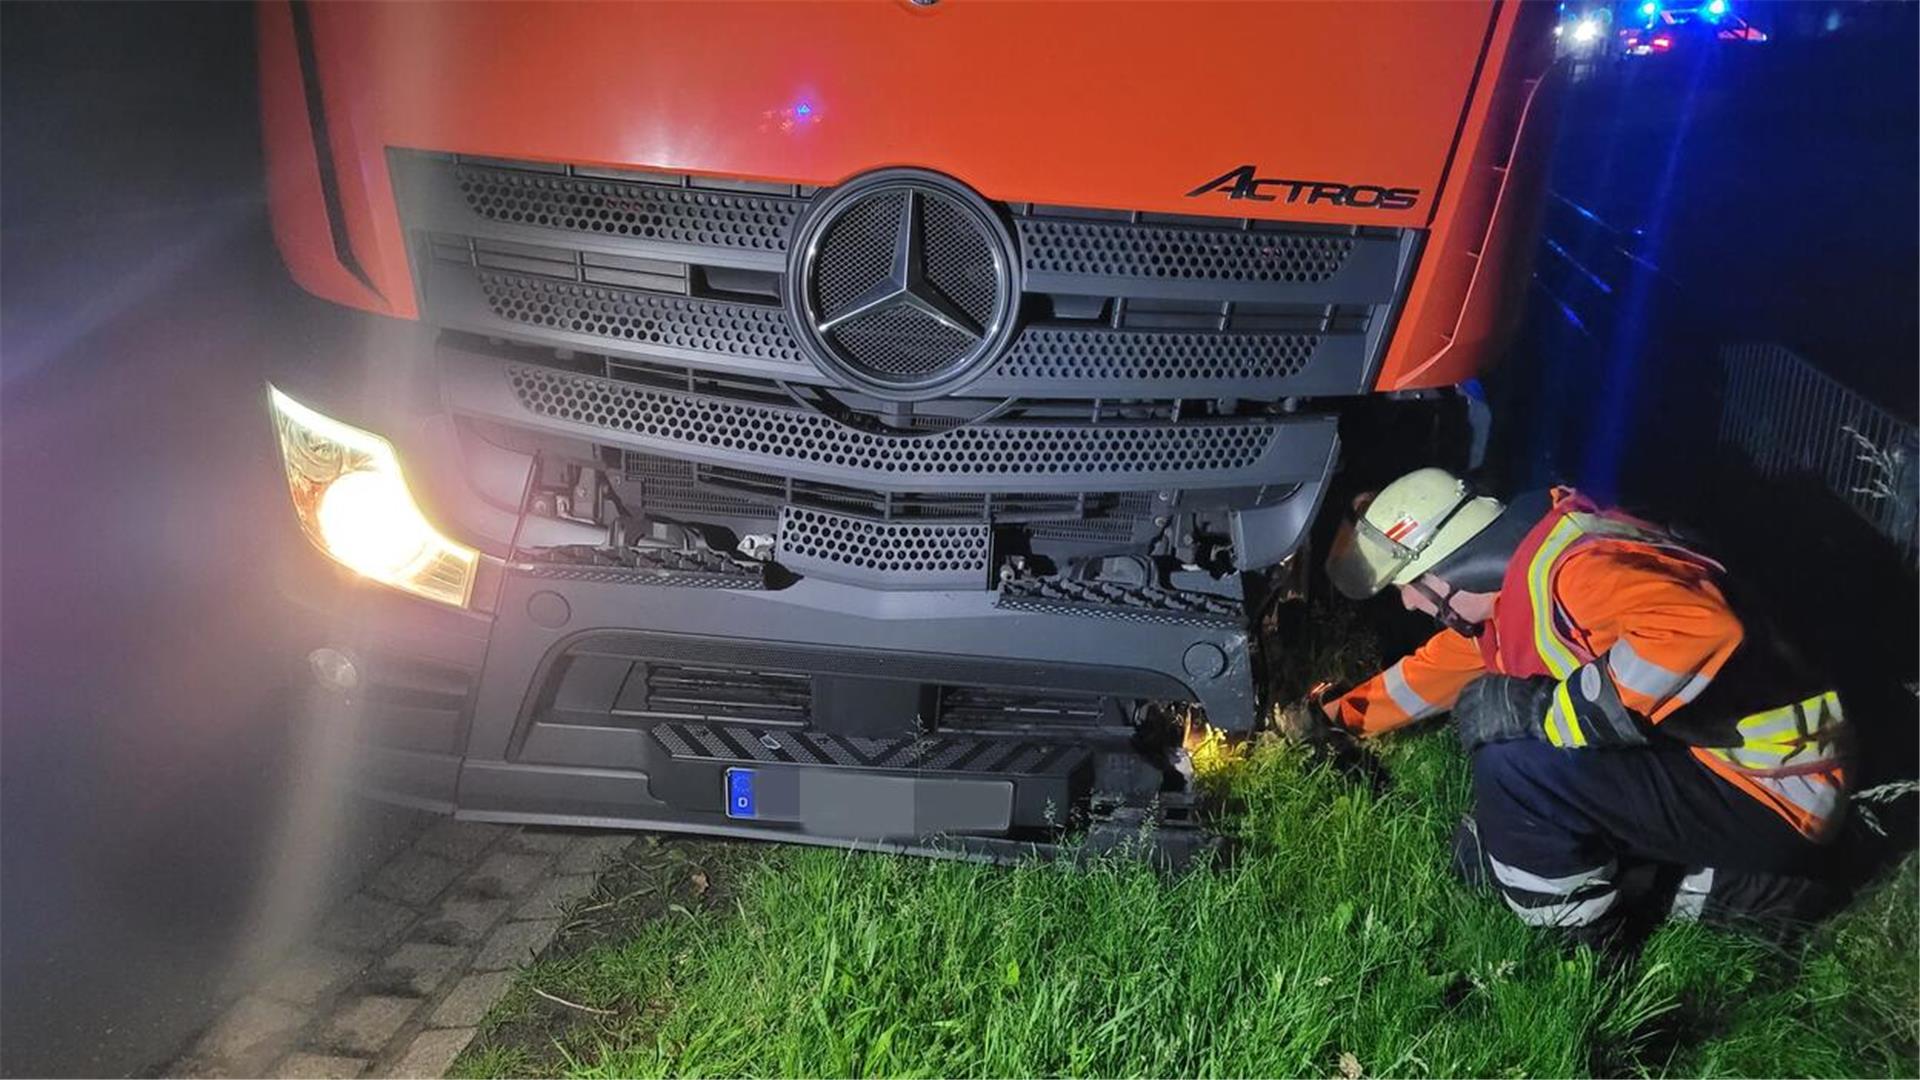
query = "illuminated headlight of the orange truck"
(267, 386, 480, 605)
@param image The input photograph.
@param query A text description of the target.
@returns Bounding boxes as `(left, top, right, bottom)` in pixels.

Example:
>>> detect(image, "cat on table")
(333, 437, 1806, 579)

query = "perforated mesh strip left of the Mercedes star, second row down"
(480, 273, 803, 363)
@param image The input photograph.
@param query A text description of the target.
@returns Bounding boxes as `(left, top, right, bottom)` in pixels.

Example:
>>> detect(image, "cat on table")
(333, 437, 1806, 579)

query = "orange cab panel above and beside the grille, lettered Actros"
(259, 0, 1553, 390)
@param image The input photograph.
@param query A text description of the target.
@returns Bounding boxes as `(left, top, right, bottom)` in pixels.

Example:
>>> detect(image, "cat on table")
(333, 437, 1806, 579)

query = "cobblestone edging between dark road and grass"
(169, 819, 636, 1076)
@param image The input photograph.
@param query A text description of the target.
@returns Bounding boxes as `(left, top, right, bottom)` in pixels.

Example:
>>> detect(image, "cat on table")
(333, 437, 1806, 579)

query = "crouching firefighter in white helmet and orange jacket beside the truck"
(1325, 469, 1847, 944)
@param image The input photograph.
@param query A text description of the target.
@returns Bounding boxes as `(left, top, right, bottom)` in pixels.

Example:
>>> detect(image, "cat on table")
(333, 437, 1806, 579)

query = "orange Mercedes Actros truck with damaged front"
(259, 0, 1553, 857)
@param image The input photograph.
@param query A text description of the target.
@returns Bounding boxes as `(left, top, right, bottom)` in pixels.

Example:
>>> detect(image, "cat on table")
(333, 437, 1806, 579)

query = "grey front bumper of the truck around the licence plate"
(291, 538, 1254, 846)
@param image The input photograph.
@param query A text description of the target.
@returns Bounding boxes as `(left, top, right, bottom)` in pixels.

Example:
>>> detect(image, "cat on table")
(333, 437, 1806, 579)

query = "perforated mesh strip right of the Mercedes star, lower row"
(995, 327, 1321, 380)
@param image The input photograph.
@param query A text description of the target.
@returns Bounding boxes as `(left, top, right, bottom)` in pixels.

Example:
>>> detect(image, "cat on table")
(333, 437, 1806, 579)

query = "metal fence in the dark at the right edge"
(1720, 344, 1920, 563)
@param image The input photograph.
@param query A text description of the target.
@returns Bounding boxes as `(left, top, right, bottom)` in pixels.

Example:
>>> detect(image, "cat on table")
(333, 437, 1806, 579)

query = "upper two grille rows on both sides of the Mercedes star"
(394, 152, 1419, 400)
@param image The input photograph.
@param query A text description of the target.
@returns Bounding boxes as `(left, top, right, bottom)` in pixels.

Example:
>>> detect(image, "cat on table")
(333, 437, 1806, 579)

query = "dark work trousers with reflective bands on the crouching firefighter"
(1473, 740, 1843, 936)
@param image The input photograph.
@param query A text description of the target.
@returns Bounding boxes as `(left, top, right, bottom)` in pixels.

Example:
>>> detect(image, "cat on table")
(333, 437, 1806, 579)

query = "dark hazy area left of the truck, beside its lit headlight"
(0, 4, 432, 1076)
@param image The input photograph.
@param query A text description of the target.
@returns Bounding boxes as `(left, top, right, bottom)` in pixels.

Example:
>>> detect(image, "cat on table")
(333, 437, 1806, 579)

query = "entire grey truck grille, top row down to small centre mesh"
(405, 150, 1382, 588)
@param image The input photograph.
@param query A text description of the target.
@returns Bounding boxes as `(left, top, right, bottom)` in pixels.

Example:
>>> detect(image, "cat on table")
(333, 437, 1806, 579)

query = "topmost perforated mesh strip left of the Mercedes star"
(455, 165, 801, 252)
